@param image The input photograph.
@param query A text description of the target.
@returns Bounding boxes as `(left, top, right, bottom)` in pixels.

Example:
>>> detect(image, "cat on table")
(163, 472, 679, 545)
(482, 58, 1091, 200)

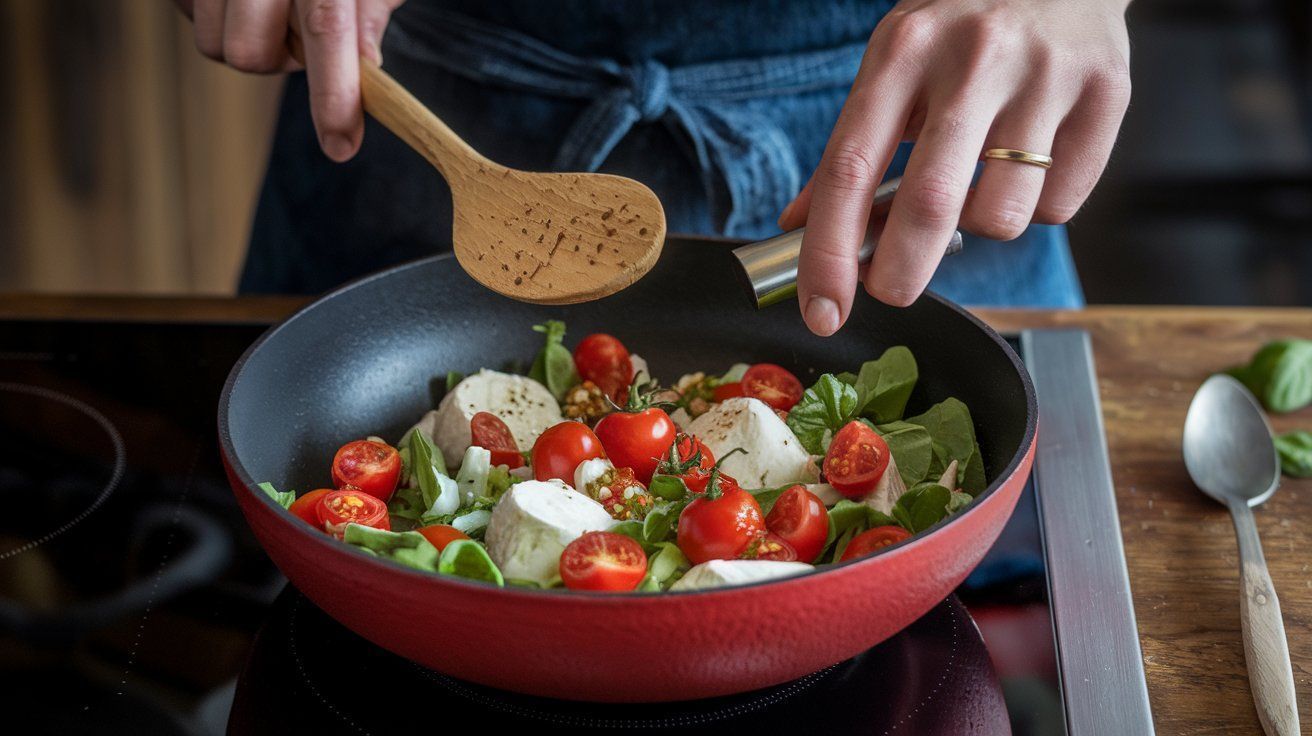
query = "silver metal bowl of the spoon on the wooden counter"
(1183, 374, 1281, 506)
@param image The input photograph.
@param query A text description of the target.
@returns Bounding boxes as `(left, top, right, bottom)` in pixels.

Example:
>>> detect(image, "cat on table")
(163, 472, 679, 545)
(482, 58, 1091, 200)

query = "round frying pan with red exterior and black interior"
(219, 234, 1036, 702)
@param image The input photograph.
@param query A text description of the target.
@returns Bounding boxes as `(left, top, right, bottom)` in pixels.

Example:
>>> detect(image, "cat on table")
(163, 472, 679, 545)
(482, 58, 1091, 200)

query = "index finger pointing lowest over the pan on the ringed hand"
(790, 42, 920, 336)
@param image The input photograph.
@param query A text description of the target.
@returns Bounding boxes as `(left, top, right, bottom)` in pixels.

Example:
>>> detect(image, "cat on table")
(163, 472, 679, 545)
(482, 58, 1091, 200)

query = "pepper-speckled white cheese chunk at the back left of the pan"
(420, 370, 564, 467)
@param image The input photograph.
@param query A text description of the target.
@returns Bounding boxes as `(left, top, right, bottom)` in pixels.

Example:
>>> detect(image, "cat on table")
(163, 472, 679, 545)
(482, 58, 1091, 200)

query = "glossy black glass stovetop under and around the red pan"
(0, 321, 1064, 736)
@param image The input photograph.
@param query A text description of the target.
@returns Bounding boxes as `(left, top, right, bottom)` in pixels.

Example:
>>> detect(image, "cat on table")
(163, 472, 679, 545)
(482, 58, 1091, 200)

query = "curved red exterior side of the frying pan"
(224, 443, 1034, 702)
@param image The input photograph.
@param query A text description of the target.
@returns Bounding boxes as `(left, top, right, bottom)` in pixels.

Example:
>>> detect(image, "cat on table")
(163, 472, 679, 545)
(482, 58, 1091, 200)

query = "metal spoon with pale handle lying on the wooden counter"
(1183, 375, 1299, 736)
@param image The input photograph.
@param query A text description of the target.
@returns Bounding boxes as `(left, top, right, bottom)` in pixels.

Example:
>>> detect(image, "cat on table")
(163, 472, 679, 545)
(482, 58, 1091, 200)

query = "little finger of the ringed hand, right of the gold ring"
(1034, 59, 1130, 224)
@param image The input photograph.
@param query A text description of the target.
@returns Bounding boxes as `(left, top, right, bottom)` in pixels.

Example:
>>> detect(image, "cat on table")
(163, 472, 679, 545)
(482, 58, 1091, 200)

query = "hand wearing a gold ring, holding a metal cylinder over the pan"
(779, 0, 1130, 335)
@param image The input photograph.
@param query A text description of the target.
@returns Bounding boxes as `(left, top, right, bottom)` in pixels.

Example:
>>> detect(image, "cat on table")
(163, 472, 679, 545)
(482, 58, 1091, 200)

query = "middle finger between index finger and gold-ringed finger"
(865, 98, 996, 307)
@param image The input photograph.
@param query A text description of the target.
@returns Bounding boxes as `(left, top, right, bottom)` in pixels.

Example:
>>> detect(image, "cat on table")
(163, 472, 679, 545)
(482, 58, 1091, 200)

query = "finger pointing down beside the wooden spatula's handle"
(297, 0, 365, 161)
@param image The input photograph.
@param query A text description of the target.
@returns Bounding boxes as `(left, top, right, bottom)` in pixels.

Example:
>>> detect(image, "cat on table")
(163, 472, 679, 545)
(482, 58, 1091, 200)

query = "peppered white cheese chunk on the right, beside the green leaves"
(687, 396, 820, 488)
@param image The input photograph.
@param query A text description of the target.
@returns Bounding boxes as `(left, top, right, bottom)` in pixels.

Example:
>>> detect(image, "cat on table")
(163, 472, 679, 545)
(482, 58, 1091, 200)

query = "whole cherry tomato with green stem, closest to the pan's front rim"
(678, 470, 765, 564)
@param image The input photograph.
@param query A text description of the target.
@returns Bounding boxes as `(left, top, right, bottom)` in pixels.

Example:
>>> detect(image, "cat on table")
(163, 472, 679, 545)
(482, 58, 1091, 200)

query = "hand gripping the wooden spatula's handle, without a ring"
(176, 0, 404, 161)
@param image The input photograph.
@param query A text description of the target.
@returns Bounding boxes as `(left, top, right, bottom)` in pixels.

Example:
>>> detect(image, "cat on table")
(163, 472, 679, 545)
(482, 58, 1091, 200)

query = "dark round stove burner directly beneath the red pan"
(228, 586, 1009, 735)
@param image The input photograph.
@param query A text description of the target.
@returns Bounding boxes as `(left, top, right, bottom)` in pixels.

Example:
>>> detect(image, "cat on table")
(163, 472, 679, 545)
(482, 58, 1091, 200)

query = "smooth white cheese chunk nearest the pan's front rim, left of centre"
(483, 480, 614, 586)
